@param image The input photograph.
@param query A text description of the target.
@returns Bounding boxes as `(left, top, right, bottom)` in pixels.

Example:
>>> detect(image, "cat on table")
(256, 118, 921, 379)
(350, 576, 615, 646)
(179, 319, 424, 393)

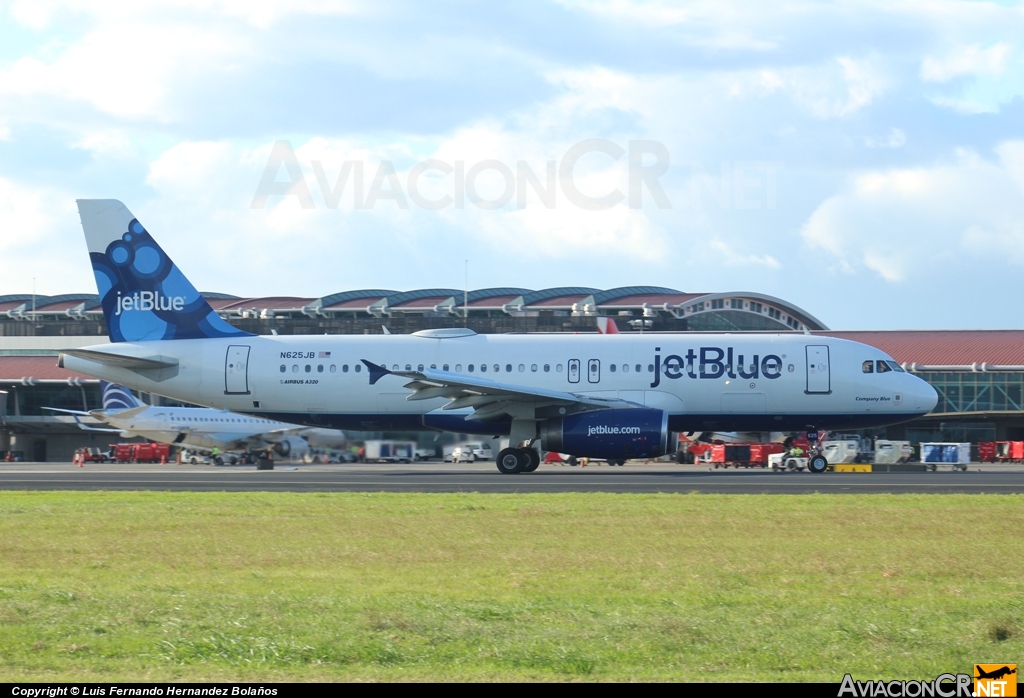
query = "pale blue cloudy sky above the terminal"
(0, 0, 1024, 330)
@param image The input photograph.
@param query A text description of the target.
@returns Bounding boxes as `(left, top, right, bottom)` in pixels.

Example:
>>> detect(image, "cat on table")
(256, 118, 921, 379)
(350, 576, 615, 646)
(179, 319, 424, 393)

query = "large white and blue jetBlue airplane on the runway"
(59, 200, 938, 474)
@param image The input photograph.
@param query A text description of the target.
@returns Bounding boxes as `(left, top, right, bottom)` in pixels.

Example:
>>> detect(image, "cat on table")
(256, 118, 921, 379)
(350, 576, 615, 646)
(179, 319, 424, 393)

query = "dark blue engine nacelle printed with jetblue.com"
(541, 407, 669, 460)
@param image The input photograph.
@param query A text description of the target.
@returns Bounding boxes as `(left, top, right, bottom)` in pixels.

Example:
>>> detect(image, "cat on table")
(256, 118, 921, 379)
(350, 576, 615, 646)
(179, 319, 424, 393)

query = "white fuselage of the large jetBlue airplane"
(63, 333, 936, 434)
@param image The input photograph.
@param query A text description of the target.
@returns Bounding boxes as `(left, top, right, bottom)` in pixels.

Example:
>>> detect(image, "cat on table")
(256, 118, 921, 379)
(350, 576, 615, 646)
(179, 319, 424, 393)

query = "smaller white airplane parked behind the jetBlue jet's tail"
(46, 381, 345, 459)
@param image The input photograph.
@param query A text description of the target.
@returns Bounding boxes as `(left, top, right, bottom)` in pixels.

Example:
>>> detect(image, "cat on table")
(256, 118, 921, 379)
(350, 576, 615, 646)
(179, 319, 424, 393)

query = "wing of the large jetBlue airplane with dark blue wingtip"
(362, 359, 630, 421)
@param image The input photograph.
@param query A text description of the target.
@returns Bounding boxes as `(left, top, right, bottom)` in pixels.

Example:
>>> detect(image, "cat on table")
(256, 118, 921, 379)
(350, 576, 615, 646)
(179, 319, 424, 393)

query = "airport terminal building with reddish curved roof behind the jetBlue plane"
(0, 287, 1024, 461)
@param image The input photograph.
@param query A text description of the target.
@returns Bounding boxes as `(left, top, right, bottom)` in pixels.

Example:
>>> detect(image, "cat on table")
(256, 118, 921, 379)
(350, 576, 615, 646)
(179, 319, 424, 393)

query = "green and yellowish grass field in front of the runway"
(0, 492, 1024, 682)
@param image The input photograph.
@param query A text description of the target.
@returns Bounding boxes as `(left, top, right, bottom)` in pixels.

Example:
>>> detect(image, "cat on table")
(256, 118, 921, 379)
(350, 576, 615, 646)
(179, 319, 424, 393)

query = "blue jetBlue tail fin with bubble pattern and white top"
(78, 199, 251, 342)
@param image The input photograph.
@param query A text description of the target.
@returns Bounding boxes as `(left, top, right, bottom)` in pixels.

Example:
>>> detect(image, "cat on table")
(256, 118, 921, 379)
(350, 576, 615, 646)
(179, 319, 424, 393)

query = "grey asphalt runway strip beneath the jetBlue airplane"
(0, 464, 1024, 494)
